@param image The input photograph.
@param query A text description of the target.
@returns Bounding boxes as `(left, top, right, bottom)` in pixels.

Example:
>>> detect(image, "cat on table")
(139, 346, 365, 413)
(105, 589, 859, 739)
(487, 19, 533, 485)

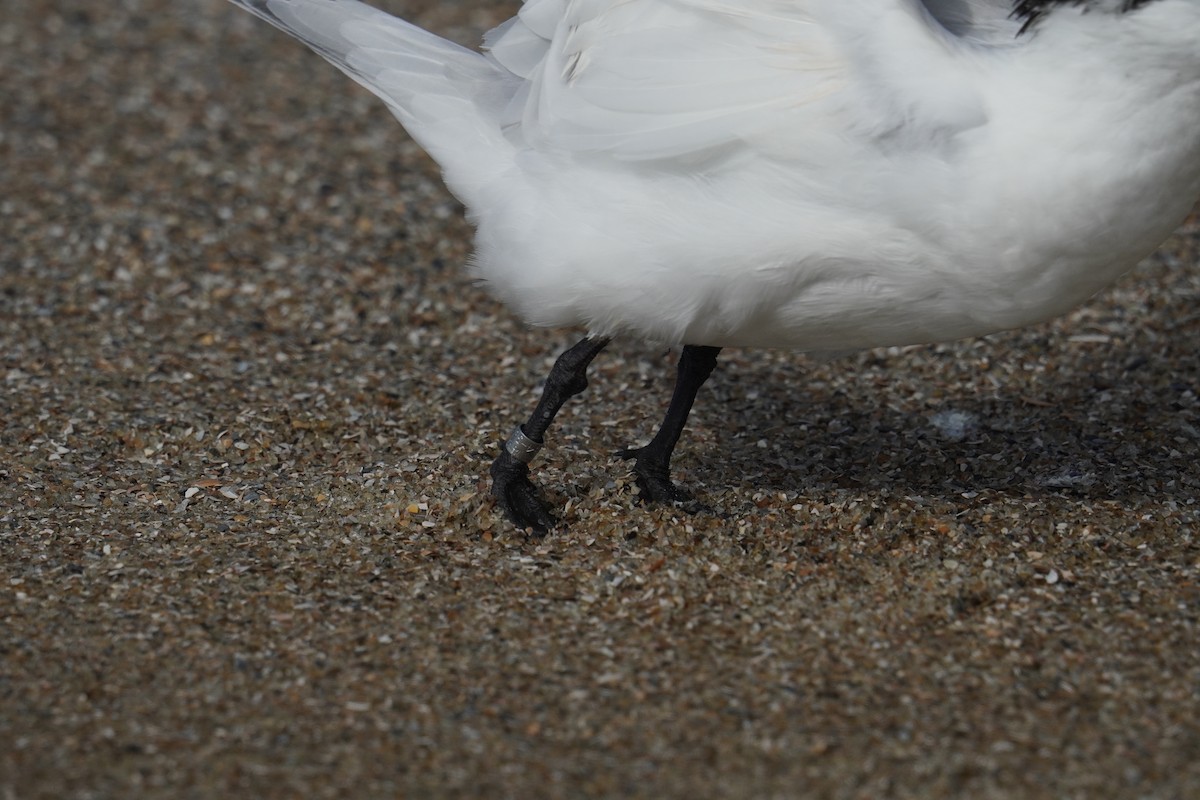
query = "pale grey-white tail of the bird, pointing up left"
(230, 0, 516, 201)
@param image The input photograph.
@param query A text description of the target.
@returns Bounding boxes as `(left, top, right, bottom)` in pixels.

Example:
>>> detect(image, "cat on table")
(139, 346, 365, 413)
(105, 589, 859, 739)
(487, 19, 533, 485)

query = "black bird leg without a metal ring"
(617, 344, 721, 503)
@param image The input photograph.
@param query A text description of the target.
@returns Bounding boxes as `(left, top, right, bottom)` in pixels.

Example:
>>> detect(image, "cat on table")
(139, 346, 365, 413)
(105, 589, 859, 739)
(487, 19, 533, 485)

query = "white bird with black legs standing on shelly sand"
(218, 0, 1200, 535)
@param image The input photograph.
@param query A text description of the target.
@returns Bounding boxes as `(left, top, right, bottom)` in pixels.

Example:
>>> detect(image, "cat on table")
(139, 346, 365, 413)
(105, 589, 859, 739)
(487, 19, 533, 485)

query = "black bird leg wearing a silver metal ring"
(492, 336, 610, 535)
